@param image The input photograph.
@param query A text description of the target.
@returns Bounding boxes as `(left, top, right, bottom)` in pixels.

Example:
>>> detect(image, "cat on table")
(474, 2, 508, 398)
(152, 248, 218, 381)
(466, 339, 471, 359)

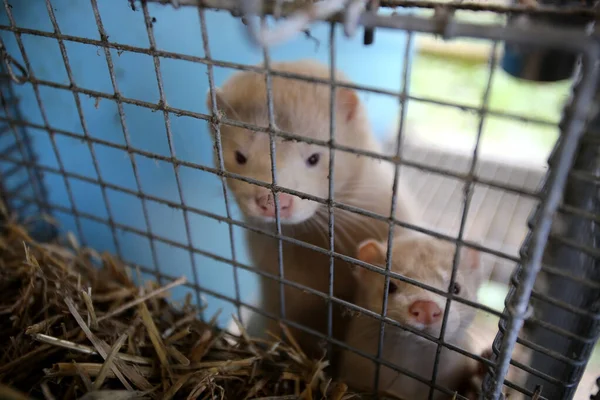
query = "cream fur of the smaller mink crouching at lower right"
(340, 234, 482, 400)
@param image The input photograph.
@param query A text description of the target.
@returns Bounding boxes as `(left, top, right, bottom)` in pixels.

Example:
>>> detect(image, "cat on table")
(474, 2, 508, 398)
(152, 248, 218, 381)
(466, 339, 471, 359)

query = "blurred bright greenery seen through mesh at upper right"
(408, 53, 570, 161)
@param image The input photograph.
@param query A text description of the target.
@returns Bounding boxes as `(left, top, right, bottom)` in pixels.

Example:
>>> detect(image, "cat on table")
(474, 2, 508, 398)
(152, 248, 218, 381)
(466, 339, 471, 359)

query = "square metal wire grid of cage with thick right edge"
(0, 0, 598, 398)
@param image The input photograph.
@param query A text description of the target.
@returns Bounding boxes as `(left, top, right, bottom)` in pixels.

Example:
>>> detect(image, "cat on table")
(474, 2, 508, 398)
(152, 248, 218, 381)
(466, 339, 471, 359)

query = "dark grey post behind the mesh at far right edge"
(524, 83, 600, 399)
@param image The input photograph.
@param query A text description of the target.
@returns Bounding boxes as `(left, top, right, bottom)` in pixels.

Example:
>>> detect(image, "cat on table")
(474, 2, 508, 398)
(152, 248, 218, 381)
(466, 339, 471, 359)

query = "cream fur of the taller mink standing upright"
(207, 60, 415, 366)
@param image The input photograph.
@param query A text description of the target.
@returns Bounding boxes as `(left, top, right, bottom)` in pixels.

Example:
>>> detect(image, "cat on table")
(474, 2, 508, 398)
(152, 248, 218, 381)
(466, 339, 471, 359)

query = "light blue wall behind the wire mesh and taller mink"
(0, 0, 406, 323)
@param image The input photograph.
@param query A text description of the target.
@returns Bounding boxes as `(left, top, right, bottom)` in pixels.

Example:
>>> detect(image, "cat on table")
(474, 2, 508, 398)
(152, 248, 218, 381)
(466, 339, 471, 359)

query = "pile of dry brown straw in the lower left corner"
(0, 208, 354, 400)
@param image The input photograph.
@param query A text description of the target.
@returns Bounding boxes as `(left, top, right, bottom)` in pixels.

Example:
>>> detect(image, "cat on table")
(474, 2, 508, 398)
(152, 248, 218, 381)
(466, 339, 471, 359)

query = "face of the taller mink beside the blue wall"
(207, 61, 372, 228)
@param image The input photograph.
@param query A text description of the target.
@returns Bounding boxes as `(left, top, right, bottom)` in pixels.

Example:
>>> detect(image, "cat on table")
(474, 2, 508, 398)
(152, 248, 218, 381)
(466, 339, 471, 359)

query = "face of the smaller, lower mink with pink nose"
(357, 236, 481, 340)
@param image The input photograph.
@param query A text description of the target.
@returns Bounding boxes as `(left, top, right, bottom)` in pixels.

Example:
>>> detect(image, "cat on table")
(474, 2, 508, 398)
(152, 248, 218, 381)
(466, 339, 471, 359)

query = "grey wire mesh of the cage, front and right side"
(0, 0, 600, 399)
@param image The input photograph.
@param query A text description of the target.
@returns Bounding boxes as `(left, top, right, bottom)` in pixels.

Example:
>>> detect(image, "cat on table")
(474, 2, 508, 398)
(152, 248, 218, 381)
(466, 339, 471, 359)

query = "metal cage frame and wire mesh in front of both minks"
(0, 0, 600, 399)
